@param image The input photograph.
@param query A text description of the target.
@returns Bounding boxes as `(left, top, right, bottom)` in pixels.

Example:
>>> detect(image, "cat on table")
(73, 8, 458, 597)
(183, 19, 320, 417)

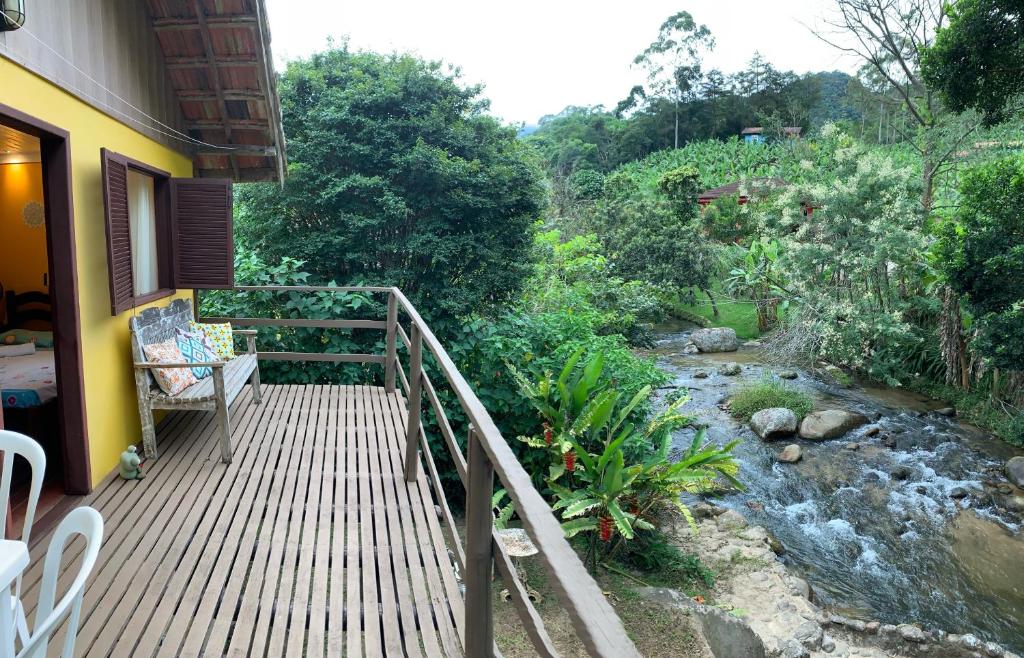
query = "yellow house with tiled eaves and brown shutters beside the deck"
(0, 0, 285, 493)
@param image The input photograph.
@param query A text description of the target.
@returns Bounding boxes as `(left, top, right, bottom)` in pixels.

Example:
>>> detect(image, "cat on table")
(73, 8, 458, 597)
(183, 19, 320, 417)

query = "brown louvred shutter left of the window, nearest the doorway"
(100, 148, 135, 315)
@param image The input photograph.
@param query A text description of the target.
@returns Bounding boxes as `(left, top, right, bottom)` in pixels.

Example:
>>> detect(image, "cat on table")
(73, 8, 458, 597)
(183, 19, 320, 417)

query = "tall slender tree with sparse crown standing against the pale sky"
(630, 11, 715, 148)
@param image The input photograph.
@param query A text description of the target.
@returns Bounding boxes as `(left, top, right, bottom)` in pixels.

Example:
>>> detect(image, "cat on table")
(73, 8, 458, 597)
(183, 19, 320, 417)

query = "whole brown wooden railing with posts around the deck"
(196, 286, 640, 658)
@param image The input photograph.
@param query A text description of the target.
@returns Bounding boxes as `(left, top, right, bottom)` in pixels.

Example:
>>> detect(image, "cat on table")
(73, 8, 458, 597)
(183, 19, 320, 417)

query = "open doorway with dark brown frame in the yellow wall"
(0, 105, 91, 540)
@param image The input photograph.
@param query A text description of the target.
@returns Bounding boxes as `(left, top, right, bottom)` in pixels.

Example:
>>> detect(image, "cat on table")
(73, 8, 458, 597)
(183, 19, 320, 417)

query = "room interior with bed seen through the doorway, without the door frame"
(0, 126, 63, 515)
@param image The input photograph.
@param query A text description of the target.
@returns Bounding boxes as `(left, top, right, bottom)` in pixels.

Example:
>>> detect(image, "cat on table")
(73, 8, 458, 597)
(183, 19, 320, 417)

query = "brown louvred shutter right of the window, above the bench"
(171, 178, 234, 288)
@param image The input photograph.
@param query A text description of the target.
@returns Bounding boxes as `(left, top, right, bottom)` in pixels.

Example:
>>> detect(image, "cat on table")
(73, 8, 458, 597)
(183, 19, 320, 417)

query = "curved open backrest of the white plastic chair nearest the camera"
(17, 508, 103, 658)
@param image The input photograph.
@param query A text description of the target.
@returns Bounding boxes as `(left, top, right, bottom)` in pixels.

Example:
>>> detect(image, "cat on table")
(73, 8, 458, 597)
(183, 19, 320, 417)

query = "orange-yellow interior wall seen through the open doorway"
(0, 163, 47, 300)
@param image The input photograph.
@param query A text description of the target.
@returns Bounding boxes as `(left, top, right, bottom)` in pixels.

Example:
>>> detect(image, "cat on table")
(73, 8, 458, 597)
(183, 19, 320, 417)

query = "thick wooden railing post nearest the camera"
(464, 427, 495, 658)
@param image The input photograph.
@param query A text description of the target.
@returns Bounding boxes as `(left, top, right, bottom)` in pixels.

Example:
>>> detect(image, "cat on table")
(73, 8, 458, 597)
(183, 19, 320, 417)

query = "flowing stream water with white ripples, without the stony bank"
(655, 327, 1024, 652)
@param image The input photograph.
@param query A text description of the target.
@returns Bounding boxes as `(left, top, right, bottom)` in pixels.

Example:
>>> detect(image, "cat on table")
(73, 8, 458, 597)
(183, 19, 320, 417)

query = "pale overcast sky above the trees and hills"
(267, 0, 856, 124)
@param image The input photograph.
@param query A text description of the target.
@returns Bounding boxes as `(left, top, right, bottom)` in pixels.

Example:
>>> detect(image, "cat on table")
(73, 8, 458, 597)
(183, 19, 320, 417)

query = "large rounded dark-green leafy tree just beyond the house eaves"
(238, 47, 543, 317)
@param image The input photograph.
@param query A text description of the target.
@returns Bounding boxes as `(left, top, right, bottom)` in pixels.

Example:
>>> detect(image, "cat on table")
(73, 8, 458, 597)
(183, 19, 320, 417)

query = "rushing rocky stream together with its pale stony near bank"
(654, 326, 1024, 658)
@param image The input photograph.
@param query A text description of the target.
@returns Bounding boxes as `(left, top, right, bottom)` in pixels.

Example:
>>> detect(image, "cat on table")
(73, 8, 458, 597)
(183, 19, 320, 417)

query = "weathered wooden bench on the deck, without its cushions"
(129, 299, 262, 464)
